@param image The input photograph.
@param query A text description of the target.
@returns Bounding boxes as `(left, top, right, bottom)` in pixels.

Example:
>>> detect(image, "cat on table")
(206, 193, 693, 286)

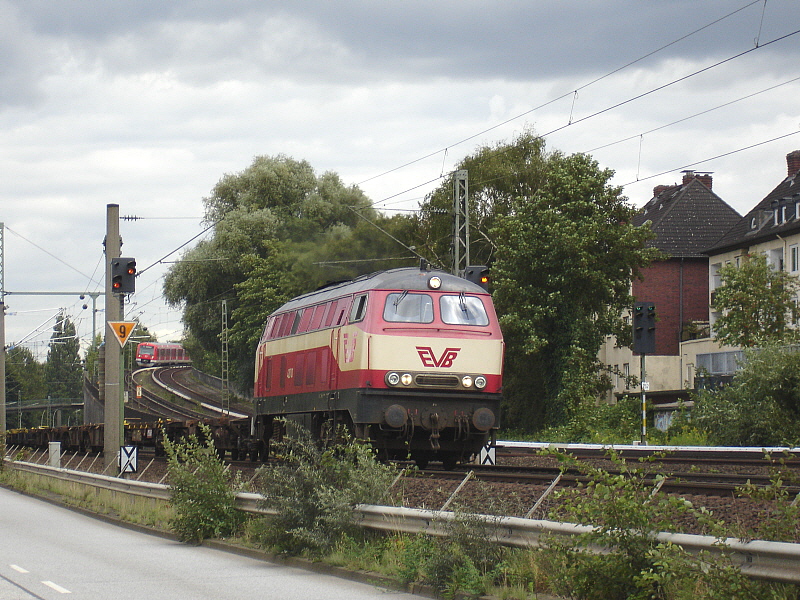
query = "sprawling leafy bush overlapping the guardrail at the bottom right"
(542, 452, 797, 600)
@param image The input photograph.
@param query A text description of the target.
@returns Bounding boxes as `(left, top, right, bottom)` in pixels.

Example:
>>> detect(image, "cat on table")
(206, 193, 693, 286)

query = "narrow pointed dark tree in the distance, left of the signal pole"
(45, 312, 83, 398)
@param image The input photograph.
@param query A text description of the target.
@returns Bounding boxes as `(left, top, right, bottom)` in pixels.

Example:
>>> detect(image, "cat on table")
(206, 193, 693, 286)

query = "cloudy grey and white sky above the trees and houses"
(0, 0, 800, 355)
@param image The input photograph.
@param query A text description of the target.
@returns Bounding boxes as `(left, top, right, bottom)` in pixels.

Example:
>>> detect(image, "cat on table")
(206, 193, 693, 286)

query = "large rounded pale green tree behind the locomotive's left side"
(164, 155, 410, 391)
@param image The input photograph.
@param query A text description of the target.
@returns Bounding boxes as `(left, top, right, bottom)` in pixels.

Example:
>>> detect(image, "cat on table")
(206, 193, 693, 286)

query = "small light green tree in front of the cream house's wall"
(714, 254, 800, 348)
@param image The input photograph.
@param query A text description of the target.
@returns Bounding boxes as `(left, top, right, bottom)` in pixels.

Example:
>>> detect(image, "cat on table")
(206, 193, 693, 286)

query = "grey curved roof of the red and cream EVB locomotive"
(275, 267, 488, 313)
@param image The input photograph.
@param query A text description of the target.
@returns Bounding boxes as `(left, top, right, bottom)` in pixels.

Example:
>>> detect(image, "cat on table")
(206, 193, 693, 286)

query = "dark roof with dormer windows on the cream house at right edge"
(708, 173, 800, 254)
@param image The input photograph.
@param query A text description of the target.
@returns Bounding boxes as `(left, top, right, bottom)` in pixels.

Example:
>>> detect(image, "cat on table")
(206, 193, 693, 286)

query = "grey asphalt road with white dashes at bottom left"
(0, 488, 419, 600)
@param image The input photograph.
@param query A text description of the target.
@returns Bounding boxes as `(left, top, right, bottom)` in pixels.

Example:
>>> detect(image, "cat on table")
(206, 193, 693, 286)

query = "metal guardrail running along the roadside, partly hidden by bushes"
(5, 459, 800, 583)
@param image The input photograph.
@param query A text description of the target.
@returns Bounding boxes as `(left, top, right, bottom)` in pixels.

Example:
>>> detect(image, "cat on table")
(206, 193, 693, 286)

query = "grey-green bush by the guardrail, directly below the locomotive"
(255, 421, 396, 554)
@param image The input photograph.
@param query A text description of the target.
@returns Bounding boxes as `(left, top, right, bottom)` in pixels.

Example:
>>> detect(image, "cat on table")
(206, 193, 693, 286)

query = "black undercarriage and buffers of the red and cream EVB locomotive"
(256, 389, 500, 468)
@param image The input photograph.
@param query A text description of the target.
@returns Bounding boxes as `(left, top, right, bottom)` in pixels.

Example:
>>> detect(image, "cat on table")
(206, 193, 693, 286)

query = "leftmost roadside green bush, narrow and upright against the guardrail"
(164, 425, 243, 544)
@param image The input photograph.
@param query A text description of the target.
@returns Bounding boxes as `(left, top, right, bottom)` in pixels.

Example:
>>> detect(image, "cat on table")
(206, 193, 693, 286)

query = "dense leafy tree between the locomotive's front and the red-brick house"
(492, 152, 658, 428)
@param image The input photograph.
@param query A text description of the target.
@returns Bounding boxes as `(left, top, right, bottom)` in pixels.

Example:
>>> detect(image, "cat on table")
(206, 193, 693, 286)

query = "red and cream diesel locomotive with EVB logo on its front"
(254, 264, 504, 468)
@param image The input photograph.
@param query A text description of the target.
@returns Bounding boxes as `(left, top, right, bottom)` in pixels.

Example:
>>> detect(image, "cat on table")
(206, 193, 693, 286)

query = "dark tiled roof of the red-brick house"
(633, 178, 742, 258)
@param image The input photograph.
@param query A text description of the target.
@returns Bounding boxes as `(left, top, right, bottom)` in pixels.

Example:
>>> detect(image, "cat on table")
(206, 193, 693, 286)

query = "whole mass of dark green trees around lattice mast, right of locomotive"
(416, 131, 658, 429)
